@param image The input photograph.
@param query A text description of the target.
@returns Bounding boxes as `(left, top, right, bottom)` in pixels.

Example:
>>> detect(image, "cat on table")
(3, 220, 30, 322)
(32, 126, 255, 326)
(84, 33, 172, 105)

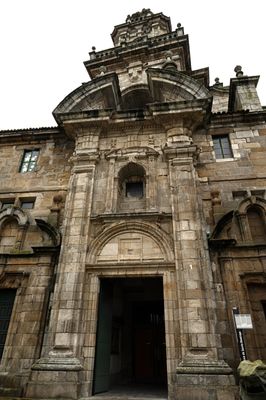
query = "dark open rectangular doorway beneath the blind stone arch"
(93, 278, 167, 394)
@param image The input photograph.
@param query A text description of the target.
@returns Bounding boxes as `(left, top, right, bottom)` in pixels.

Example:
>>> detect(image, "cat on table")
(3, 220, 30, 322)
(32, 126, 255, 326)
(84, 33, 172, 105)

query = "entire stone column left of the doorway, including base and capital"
(27, 130, 98, 398)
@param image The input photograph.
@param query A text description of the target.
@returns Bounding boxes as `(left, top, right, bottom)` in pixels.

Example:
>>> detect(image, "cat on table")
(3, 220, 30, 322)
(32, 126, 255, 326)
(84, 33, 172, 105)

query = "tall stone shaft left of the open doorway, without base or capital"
(51, 165, 95, 353)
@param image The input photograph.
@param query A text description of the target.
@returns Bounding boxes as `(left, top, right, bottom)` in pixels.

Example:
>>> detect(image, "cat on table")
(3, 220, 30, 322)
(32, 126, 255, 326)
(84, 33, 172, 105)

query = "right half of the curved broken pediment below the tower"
(147, 68, 210, 102)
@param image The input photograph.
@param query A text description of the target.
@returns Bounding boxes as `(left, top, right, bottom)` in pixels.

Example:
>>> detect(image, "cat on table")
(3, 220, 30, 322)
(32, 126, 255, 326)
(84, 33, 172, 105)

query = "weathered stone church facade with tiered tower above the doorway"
(0, 9, 266, 400)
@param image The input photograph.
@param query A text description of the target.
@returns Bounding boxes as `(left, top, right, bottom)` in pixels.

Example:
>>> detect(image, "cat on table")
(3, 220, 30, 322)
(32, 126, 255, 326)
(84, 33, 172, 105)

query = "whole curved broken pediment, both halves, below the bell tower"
(53, 68, 210, 124)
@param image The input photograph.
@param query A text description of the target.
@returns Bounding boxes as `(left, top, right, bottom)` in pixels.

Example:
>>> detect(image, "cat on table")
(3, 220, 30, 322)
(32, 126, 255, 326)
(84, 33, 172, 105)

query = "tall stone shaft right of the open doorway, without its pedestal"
(169, 157, 221, 361)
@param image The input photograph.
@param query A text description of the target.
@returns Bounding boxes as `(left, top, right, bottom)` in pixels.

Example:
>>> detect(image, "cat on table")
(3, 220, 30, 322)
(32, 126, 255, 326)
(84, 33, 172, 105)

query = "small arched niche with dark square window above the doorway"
(118, 162, 146, 209)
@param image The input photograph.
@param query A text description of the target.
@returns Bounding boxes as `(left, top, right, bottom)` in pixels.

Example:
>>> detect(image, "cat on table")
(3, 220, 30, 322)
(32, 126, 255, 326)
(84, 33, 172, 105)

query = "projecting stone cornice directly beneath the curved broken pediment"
(57, 98, 212, 137)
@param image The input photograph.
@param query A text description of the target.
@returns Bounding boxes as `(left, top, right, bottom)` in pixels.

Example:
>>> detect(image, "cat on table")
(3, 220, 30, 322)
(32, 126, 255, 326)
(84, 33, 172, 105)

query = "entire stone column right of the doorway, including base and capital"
(165, 136, 235, 400)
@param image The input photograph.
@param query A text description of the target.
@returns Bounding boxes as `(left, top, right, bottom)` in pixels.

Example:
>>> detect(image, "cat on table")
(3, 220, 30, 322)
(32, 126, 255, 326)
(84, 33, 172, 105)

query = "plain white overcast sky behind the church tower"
(0, 0, 266, 130)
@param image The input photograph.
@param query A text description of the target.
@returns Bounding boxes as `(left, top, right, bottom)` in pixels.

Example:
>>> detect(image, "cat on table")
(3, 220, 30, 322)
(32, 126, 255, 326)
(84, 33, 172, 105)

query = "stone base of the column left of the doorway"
(25, 350, 83, 399)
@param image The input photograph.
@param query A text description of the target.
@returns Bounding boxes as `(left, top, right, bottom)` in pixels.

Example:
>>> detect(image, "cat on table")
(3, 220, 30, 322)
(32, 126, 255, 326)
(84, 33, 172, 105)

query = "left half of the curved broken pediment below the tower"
(53, 73, 120, 123)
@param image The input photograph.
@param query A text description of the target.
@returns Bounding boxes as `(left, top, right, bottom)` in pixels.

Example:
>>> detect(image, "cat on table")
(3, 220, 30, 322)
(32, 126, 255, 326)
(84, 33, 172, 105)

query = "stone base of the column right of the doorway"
(175, 360, 239, 400)
